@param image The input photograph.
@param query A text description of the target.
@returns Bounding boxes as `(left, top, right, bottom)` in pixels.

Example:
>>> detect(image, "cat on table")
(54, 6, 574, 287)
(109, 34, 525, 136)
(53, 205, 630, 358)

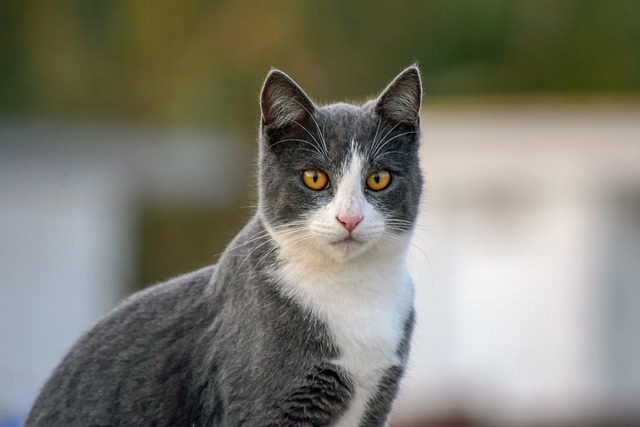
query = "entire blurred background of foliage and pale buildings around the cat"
(0, 0, 640, 427)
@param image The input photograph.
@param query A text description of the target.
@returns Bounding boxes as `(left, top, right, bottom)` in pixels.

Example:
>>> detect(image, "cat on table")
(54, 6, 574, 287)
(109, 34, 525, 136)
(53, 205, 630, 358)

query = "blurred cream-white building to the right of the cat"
(396, 104, 640, 425)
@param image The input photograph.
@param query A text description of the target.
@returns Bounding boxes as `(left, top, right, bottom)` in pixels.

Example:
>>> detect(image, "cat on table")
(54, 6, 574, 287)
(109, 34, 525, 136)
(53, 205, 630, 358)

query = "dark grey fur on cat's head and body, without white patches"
(26, 67, 422, 427)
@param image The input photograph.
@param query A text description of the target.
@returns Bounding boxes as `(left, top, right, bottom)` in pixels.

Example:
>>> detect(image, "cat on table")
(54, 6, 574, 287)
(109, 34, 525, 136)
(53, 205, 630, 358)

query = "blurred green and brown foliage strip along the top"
(0, 0, 640, 134)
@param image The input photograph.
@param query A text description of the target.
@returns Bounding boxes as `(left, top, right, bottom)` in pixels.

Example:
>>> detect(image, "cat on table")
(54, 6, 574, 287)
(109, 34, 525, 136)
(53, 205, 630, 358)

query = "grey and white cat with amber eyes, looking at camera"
(26, 66, 422, 427)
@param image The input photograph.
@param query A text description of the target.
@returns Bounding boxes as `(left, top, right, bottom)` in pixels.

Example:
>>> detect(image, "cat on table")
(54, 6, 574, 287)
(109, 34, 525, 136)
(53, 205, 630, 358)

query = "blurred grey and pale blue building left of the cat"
(0, 120, 251, 422)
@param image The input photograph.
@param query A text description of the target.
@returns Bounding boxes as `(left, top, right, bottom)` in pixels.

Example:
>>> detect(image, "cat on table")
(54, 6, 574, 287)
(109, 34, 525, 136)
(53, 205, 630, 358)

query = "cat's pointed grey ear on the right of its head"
(375, 65, 422, 125)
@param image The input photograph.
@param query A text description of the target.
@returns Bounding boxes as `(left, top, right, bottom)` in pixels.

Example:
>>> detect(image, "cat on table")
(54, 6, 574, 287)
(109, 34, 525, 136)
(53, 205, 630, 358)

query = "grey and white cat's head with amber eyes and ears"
(259, 66, 422, 264)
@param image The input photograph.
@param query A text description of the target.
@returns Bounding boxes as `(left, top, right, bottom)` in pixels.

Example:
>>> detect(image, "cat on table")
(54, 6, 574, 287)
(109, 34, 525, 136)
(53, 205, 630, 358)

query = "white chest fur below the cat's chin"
(280, 251, 413, 426)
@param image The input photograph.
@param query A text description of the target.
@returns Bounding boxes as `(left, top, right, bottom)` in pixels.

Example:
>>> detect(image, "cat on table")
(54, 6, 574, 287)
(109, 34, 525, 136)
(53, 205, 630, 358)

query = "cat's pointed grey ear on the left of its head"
(260, 70, 316, 130)
